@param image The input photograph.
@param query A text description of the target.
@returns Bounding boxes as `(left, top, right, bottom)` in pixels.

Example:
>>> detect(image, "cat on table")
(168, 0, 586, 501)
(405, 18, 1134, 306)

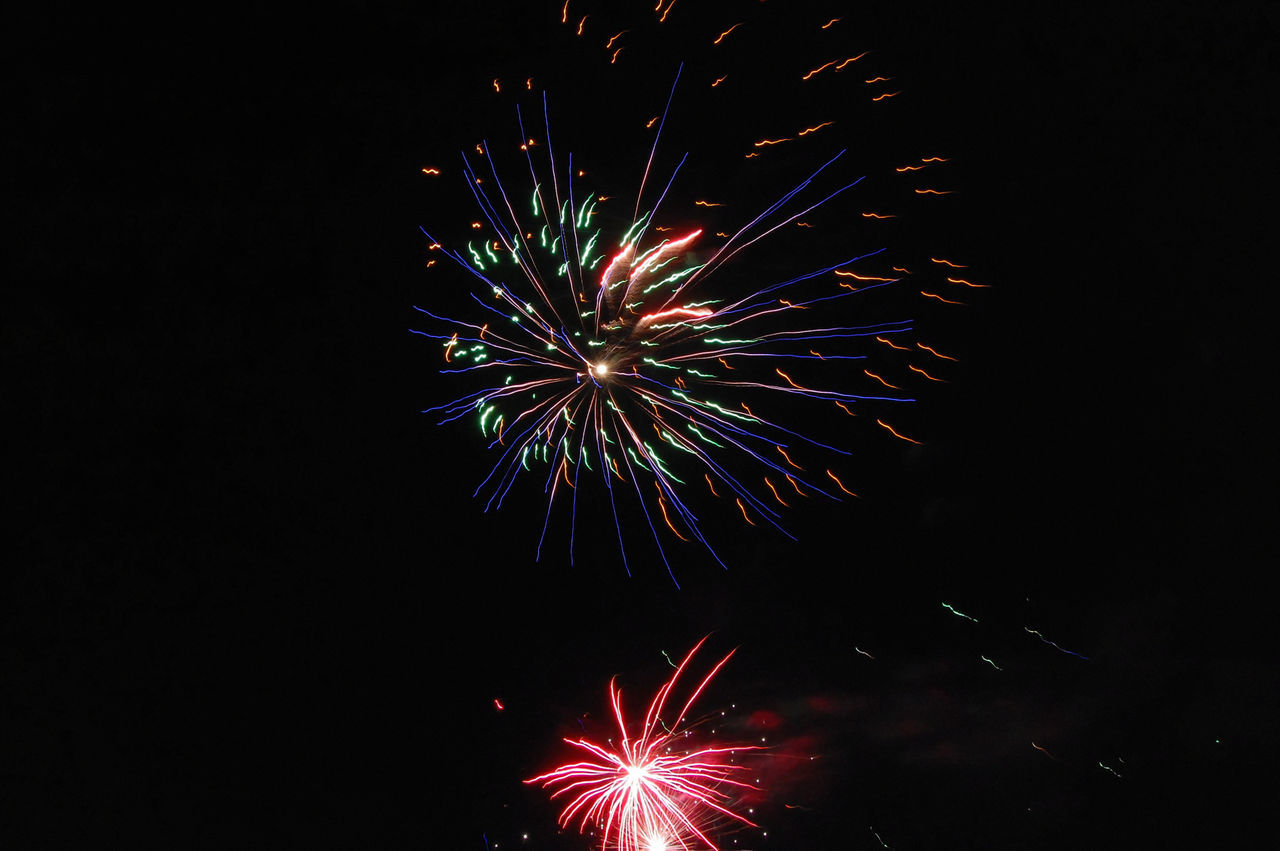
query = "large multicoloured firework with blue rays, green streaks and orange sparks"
(413, 4, 967, 578)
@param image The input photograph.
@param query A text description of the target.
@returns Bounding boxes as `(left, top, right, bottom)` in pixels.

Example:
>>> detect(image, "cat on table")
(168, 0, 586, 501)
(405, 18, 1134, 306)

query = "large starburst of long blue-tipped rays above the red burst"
(415, 68, 913, 571)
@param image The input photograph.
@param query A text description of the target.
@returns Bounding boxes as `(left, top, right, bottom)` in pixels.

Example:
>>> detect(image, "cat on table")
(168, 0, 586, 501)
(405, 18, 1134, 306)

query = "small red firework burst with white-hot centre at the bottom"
(525, 639, 759, 851)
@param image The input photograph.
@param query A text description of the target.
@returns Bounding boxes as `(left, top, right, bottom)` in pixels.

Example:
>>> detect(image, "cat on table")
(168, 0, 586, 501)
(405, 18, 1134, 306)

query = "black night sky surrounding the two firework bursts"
(0, 0, 1280, 851)
